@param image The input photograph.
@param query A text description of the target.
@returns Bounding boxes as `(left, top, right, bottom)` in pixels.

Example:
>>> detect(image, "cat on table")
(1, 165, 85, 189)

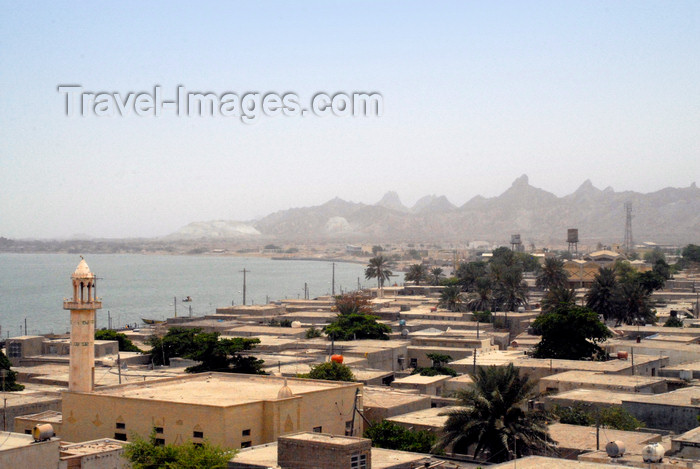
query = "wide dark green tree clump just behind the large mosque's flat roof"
(149, 327, 264, 374)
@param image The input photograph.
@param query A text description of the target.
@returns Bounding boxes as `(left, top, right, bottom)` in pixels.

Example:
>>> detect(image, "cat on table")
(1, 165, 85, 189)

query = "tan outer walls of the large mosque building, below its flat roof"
(62, 384, 362, 448)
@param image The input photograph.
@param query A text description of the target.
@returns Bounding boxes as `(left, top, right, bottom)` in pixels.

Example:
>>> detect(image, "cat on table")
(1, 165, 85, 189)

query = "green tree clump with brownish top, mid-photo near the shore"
(323, 293, 391, 340)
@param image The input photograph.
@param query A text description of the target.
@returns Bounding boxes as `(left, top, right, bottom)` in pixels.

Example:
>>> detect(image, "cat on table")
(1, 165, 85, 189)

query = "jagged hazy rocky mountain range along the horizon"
(168, 175, 700, 245)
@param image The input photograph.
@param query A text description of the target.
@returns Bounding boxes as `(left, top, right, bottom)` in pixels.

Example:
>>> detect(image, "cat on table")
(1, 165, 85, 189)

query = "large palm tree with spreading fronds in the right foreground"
(438, 363, 553, 463)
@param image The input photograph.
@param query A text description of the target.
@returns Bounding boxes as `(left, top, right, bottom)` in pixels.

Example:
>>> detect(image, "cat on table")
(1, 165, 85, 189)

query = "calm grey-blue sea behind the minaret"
(0, 254, 374, 338)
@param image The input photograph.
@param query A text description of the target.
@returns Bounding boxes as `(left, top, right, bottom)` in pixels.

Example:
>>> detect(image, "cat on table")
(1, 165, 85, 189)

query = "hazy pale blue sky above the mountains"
(0, 0, 700, 237)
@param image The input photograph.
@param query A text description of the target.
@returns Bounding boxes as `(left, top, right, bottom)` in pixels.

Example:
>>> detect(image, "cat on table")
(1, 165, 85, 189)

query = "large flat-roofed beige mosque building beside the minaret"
(62, 373, 362, 448)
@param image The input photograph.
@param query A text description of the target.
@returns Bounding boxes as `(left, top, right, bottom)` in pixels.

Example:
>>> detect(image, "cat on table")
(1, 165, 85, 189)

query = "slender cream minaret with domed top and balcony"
(63, 256, 102, 392)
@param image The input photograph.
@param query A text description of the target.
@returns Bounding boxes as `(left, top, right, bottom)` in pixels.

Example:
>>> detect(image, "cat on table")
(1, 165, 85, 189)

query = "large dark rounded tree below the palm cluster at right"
(533, 304, 612, 360)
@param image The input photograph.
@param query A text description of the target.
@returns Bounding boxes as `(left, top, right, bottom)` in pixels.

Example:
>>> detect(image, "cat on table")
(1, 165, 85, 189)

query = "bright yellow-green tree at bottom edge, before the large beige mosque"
(124, 431, 237, 469)
